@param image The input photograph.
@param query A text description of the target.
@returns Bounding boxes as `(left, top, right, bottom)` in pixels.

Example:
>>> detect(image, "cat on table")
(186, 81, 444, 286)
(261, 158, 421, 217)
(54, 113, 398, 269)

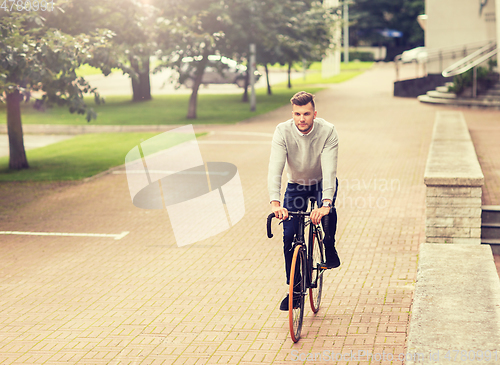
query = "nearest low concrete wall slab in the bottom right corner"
(405, 243, 500, 365)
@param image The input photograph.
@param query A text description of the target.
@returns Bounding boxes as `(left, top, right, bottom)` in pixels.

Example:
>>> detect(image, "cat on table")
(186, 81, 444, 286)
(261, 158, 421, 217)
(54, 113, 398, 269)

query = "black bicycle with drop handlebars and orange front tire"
(267, 198, 329, 342)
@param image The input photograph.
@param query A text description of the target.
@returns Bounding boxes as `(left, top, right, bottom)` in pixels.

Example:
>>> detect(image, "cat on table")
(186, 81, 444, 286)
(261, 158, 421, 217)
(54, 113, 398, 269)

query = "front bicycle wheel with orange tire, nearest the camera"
(288, 245, 307, 342)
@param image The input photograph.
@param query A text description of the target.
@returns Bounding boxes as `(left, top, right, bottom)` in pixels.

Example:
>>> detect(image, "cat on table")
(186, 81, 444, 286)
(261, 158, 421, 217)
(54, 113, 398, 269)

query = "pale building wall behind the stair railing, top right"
(425, 0, 500, 74)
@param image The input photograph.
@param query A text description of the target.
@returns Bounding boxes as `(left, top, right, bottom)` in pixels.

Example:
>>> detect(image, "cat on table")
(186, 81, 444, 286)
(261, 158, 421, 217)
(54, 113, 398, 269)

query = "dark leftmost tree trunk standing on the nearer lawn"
(7, 90, 29, 170)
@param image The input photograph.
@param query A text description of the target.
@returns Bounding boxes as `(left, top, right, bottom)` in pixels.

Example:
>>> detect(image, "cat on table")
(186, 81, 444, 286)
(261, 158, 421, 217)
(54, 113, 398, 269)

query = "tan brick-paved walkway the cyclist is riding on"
(0, 65, 446, 364)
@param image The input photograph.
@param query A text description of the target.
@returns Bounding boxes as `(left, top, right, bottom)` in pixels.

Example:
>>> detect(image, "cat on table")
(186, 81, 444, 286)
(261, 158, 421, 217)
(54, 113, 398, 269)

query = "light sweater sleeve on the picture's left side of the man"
(267, 128, 286, 201)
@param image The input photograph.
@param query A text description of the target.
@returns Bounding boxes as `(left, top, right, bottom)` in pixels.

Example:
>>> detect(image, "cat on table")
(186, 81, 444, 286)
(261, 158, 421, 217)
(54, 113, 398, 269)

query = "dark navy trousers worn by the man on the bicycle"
(283, 180, 339, 285)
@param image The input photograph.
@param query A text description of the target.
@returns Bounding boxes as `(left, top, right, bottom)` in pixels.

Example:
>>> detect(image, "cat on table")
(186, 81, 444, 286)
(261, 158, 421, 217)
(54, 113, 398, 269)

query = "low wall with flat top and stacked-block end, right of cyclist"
(424, 111, 484, 244)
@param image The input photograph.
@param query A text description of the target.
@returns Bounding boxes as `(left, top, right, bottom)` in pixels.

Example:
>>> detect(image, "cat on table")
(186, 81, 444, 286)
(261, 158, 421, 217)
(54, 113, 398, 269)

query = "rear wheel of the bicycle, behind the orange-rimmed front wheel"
(308, 228, 325, 313)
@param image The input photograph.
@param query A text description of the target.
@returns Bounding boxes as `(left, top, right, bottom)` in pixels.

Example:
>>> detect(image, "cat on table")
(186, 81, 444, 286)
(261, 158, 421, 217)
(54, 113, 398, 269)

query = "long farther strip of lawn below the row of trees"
(0, 86, 321, 125)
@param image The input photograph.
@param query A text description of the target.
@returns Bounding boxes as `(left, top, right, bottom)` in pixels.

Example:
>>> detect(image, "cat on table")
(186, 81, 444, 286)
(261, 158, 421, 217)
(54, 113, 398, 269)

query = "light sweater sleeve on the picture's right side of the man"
(321, 127, 339, 200)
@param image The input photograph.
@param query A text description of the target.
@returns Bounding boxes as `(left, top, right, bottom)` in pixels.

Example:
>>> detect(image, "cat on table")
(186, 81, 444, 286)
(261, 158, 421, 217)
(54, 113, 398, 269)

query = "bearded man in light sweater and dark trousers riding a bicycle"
(268, 91, 340, 310)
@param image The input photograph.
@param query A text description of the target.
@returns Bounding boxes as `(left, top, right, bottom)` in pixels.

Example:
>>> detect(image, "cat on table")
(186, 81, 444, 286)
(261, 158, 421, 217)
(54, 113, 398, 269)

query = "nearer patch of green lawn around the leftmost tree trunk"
(0, 133, 201, 181)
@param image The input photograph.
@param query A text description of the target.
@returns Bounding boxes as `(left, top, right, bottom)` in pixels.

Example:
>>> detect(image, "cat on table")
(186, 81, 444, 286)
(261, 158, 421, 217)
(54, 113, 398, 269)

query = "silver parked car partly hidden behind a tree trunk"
(182, 55, 262, 88)
